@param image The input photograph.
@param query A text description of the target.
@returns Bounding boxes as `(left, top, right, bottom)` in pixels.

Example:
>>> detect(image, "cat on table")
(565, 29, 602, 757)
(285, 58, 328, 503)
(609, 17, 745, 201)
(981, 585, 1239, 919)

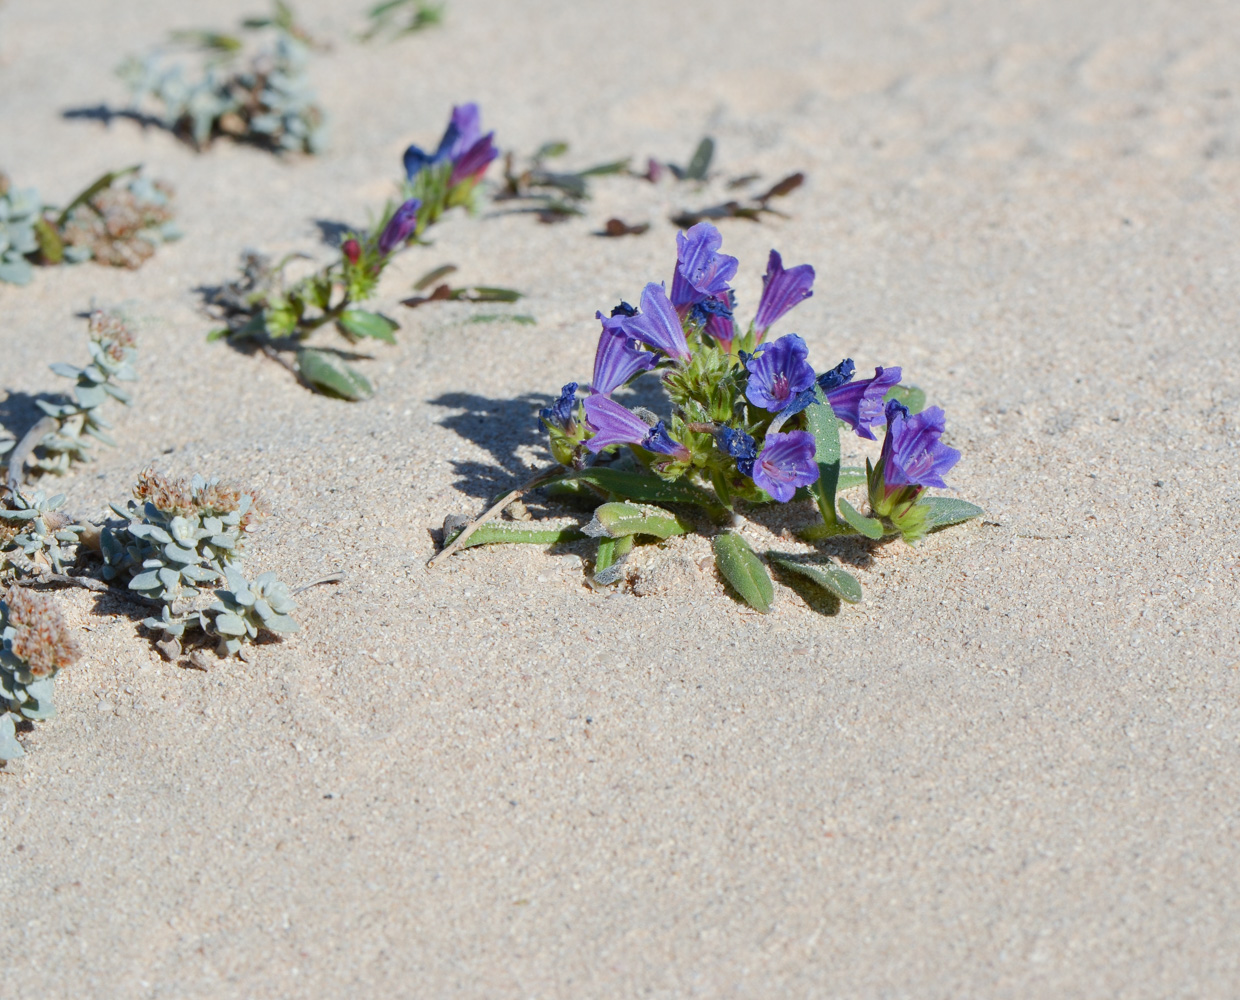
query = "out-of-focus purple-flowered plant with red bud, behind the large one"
(208, 104, 496, 400)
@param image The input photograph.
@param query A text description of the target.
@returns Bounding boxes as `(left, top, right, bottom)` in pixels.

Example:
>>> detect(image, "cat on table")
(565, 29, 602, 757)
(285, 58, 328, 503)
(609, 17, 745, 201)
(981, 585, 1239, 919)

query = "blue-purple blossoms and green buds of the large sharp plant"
(539, 222, 960, 537)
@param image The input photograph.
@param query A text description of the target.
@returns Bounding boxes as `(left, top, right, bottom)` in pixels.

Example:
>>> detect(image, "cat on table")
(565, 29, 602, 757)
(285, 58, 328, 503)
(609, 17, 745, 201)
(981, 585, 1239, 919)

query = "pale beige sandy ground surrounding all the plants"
(0, 0, 1240, 998)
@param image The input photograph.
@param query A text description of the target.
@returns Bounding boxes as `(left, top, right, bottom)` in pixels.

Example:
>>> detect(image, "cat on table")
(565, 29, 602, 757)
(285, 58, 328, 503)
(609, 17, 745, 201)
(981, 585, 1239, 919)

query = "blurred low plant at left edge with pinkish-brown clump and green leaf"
(0, 166, 181, 284)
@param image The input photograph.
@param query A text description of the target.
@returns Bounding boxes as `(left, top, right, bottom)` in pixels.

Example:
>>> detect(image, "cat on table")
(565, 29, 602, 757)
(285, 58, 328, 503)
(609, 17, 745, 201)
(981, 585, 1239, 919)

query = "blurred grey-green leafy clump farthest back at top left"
(118, 0, 326, 153)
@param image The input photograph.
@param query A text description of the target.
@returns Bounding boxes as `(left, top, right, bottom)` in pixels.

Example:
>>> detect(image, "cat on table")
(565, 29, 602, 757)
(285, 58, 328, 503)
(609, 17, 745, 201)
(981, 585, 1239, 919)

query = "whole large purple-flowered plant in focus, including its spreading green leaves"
(435, 222, 982, 612)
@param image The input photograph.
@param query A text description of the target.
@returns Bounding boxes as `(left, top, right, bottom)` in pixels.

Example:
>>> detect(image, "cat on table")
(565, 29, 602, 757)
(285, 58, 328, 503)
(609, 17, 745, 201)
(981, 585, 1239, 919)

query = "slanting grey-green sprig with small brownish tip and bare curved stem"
(4, 309, 138, 493)
